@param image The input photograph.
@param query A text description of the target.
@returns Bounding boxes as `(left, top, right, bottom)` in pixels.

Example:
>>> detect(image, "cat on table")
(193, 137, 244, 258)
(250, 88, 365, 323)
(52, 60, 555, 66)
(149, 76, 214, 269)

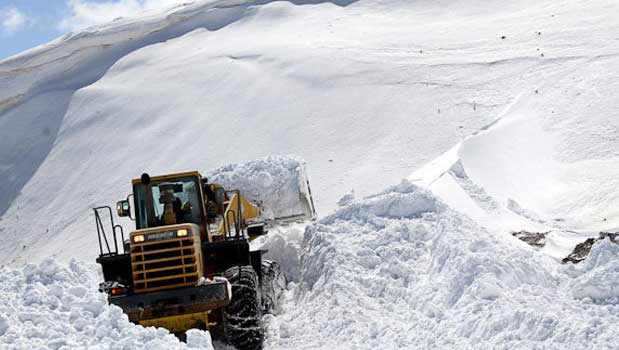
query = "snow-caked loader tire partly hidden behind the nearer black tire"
(262, 260, 287, 315)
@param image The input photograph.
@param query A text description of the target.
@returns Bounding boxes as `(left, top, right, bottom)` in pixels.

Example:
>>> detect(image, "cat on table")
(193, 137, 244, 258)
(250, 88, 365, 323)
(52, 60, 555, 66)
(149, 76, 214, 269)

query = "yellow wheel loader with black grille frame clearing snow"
(94, 172, 315, 350)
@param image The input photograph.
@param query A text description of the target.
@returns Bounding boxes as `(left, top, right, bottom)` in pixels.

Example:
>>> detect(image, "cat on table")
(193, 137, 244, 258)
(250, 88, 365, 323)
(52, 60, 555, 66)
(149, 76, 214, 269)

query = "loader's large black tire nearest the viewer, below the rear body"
(224, 266, 264, 350)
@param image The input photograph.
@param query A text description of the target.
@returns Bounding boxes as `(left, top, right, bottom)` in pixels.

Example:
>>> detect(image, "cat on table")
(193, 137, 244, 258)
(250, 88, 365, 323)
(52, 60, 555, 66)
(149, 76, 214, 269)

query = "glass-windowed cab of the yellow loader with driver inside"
(132, 172, 204, 229)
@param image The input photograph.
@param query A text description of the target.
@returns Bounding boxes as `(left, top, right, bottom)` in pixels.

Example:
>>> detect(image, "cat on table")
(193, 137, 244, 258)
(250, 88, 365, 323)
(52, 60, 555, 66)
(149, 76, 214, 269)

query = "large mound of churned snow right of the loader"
(270, 182, 619, 349)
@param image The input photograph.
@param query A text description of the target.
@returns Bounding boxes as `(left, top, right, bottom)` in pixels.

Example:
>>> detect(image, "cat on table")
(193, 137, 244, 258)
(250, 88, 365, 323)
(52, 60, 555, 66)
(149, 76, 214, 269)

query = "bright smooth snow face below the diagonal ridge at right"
(410, 55, 619, 257)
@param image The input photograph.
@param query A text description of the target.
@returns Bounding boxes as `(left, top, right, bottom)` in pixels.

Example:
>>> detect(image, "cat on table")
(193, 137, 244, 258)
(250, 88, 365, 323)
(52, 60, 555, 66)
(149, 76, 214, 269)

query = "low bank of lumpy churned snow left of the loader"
(0, 260, 213, 350)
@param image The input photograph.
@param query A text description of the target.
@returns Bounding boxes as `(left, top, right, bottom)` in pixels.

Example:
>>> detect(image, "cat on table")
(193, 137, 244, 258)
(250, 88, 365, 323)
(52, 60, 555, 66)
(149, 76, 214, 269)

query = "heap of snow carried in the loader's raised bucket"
(209, 156, 313, 219)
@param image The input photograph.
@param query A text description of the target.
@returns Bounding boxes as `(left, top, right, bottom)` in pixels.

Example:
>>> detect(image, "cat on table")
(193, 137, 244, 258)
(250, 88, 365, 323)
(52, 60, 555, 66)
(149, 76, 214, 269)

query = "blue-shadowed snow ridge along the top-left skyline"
(0, 0, 353, 217)
